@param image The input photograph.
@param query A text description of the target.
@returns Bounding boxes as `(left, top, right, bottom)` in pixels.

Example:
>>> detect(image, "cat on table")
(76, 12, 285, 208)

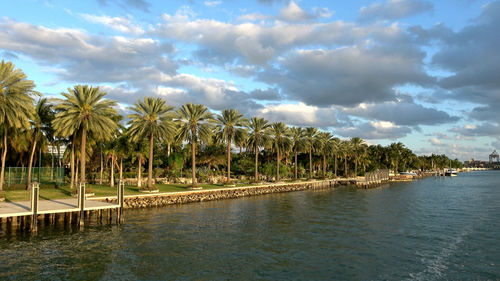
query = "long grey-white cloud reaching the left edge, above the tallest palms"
(0, 18, 177, 86)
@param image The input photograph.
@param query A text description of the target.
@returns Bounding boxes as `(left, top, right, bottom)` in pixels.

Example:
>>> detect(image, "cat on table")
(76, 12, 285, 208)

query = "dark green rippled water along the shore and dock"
(0, 171, 500, 280)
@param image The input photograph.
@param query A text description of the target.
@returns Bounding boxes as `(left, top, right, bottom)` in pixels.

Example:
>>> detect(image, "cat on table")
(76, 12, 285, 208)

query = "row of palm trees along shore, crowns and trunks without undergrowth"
(0, 61, 462, 190)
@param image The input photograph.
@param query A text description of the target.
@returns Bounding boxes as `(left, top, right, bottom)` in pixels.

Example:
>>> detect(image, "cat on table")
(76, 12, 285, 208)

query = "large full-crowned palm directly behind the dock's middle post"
(52, 85, 118, 183)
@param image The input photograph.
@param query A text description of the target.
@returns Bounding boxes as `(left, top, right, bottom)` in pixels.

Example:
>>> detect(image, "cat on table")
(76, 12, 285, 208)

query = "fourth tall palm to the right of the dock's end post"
(247, 117, 271, 182)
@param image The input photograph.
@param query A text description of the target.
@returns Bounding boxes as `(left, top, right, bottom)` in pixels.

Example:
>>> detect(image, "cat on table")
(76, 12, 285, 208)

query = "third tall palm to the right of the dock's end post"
(215, 109, 248, 184)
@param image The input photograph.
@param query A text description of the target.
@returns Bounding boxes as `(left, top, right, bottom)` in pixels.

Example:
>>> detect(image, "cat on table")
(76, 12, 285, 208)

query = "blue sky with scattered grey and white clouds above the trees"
(0, 0, 500, 160)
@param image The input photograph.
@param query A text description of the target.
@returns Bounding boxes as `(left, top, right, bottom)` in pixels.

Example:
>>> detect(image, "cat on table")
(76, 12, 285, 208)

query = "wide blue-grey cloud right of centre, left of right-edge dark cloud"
(266, 46, 434, 105)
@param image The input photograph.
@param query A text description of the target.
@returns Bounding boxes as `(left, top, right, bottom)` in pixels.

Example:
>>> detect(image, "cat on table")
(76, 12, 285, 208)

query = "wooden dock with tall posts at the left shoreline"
(0, 181, 124, 233)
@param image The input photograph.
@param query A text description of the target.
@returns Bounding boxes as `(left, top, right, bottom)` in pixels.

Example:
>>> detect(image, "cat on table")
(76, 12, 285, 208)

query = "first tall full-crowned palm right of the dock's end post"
(127, 97, 176, 190)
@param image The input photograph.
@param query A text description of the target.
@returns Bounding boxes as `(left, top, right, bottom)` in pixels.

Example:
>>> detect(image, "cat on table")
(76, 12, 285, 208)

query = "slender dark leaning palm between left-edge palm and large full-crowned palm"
(26, 98, 54, 189)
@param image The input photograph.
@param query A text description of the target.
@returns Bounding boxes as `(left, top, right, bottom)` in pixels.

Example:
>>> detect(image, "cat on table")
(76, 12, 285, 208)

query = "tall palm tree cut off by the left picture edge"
(0, 60, 38, 191)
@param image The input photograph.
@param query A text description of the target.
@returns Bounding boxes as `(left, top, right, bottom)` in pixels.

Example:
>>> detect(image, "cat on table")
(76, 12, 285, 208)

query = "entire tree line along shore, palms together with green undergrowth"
(0, 61, 461, 190)
